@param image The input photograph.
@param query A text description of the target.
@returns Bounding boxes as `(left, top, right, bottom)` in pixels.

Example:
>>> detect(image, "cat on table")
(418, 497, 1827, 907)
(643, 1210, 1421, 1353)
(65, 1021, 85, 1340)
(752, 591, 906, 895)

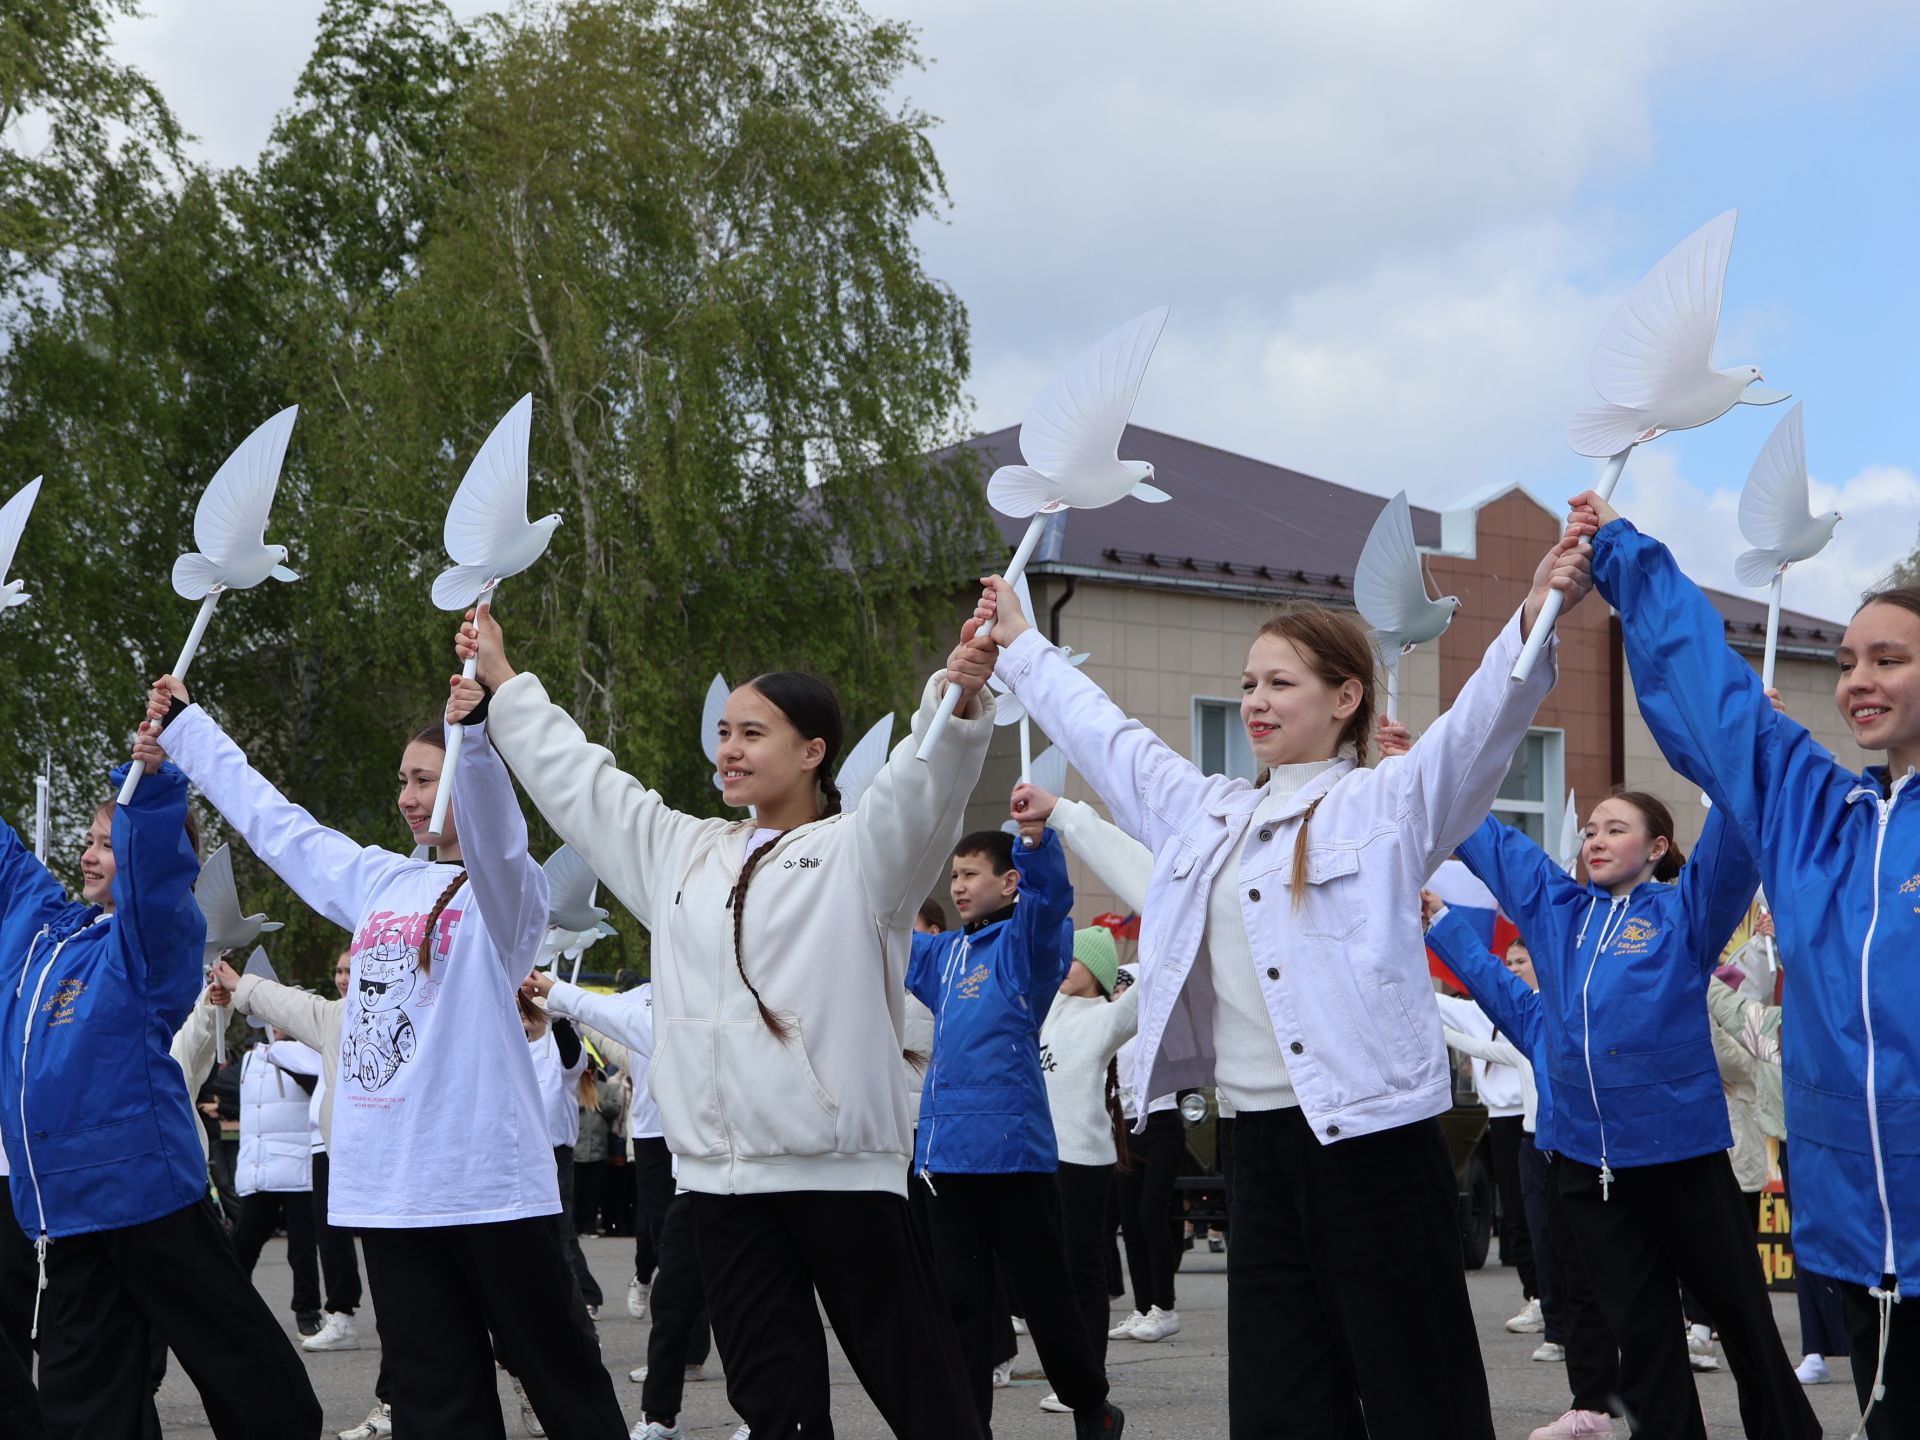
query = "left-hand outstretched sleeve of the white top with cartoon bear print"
(159, 705, 413, 931)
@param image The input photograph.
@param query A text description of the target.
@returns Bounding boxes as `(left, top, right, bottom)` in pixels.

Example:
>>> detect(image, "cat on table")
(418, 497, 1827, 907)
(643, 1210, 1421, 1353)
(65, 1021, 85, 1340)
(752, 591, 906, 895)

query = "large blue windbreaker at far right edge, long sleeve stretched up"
(1594, 520, 1920, 1284)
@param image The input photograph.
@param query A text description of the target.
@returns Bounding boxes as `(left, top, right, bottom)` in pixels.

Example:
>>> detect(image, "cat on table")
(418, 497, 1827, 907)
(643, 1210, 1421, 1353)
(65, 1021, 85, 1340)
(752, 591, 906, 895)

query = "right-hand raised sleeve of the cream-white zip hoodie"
(849, 672, 993, 925)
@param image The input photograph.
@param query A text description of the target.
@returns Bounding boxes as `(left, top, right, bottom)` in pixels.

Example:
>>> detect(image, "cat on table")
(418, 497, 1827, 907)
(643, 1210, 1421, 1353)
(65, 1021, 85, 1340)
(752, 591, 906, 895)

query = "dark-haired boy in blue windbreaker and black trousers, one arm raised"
(906, 829, 1121, 1438)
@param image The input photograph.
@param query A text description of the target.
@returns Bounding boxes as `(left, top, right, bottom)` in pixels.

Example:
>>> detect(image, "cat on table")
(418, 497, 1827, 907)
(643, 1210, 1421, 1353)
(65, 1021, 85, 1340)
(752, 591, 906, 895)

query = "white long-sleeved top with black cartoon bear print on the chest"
(161, 705, 561, 1229)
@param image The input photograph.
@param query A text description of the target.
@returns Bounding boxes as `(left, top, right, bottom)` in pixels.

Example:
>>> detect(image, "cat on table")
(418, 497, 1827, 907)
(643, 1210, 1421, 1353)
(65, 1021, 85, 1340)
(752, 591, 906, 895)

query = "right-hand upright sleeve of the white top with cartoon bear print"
(441, 724, 547, 985)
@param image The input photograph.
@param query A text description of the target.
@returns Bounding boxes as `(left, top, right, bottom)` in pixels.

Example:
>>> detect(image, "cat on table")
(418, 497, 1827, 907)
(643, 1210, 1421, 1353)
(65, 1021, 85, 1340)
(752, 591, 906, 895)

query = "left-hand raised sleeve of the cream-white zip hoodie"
(486, 672, 726, 929)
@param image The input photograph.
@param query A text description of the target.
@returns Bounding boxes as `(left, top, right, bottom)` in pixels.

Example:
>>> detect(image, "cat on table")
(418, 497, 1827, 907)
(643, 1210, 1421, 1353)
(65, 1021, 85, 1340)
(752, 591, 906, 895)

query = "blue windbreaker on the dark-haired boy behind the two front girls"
(906, 829, 1073, 1175)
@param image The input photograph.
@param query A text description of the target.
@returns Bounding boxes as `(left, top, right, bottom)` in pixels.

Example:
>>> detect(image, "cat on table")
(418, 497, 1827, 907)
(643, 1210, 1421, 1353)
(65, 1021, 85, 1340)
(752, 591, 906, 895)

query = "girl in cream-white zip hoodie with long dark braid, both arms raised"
(457, 611, 1021, 1440)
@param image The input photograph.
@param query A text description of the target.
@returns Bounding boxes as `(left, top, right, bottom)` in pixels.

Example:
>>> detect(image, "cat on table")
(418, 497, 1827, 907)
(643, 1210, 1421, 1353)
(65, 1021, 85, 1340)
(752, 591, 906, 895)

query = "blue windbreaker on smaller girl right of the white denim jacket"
(1459, 810, 1759, 1177)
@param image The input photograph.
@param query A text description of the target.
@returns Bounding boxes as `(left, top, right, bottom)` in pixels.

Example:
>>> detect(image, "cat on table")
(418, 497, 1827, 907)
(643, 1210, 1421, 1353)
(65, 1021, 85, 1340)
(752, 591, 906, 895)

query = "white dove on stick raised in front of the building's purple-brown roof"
(918, 305, 1171, 760)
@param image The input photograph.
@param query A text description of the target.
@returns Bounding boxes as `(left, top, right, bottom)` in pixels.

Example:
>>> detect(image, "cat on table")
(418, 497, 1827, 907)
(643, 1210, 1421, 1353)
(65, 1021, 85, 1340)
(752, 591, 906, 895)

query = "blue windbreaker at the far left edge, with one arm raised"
(0, 764, 207, 1240)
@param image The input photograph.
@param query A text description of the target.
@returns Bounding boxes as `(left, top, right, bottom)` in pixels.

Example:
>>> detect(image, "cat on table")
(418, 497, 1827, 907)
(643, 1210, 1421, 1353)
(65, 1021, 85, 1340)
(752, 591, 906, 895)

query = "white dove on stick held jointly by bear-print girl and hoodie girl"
(426, 396, 561, 839)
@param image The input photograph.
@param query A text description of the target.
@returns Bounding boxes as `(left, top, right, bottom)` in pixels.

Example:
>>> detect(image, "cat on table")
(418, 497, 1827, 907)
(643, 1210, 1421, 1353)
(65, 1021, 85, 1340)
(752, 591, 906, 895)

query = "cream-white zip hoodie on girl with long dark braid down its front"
(490, 674, 993, 1196)
